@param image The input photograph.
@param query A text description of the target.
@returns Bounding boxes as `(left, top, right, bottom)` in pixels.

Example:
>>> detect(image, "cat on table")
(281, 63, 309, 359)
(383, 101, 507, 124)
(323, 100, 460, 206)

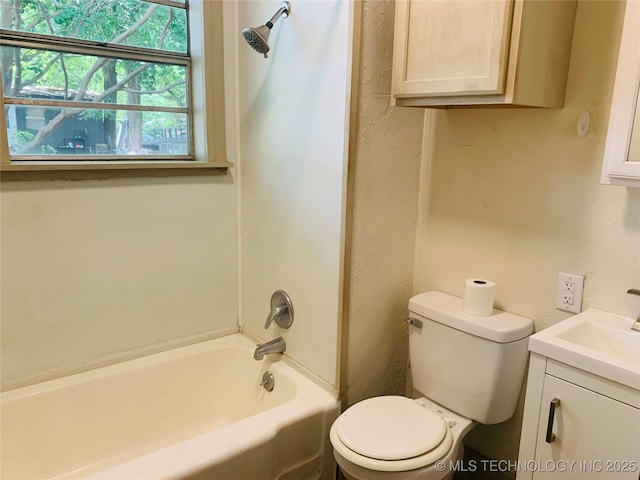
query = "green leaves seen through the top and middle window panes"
(2, 0, 187, 106)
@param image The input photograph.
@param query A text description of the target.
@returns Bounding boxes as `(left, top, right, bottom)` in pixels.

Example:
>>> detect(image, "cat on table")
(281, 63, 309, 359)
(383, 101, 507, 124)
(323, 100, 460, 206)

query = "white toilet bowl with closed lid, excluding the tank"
(329, 395, 475, 480)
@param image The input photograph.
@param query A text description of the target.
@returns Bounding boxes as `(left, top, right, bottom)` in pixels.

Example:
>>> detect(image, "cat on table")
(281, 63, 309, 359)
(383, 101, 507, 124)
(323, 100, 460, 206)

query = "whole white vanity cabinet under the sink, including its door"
(517, 353, 640, 480)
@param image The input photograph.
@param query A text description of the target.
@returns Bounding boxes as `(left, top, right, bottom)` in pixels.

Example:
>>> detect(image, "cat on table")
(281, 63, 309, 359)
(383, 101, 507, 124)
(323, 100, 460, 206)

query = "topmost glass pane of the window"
(2, 0, 187, 53)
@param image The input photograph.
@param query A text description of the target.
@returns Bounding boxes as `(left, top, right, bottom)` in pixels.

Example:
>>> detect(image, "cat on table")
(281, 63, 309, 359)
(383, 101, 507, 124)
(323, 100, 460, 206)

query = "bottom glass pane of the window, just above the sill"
(5, 105, 190, 160)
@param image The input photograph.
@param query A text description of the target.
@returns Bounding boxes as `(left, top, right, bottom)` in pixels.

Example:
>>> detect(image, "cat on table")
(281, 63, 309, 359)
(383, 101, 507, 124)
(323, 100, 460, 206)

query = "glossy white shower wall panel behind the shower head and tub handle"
(237, 0, 352, 385)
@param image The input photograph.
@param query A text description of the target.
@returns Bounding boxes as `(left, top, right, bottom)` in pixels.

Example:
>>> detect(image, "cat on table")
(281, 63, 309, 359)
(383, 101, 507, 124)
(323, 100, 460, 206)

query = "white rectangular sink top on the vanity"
(529, 309, 640, 390)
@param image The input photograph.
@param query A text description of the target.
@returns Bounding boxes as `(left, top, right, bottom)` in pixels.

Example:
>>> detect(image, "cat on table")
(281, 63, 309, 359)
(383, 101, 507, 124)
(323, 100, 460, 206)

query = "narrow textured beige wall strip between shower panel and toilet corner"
(344, 0, 423, 404)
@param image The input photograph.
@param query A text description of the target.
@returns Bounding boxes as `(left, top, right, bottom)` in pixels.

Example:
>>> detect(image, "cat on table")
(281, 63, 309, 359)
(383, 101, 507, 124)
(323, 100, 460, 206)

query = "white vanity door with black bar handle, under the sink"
(533, 375, 640, 480)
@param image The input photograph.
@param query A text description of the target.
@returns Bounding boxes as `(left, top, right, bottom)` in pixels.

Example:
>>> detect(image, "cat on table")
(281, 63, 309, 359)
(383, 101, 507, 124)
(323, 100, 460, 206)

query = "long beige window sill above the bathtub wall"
(0, 161, 233, 181)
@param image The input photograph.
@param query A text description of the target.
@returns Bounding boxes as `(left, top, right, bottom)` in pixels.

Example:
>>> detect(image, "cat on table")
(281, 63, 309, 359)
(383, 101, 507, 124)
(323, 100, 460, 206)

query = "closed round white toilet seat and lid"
(329, 396, 453, 472)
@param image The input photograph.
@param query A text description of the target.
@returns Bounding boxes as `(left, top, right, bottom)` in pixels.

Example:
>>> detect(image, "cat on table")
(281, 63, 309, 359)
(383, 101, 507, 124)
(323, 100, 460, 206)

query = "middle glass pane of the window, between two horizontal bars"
(0, 46, 187, 107)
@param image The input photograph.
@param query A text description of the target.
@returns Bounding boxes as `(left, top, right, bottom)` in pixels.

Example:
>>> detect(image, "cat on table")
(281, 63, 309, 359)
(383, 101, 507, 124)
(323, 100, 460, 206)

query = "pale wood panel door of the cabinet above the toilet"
(393, 0, 513, 97)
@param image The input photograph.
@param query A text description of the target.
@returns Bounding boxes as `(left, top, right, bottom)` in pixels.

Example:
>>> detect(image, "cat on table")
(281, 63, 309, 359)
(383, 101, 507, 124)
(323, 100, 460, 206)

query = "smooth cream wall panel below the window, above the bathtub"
(0, 175, 237, 384)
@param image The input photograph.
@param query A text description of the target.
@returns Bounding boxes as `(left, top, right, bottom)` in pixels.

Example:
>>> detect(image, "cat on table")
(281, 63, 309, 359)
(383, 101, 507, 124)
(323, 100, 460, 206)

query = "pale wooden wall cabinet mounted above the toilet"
(391, 0, 576, 108)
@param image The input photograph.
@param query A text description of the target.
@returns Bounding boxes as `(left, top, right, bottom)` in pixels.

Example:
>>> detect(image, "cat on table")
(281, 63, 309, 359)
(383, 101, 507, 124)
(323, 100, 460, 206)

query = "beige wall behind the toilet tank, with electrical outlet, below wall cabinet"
(415, 1, 640, 459)
